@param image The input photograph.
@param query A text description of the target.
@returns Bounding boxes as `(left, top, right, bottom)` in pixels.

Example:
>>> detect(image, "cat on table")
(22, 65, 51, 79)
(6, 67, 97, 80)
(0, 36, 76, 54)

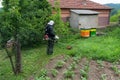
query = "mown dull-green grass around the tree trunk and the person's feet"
(0, 45, 67, 80)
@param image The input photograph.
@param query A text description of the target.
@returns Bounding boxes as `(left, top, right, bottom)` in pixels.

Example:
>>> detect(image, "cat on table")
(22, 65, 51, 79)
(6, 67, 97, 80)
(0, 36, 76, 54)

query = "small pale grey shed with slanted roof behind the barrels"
(70, 10, 99, 29)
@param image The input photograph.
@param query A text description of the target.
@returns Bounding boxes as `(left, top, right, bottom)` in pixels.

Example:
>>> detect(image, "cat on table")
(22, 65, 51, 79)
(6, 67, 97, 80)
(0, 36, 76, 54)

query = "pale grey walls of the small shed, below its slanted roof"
(70, 12, 99, 29)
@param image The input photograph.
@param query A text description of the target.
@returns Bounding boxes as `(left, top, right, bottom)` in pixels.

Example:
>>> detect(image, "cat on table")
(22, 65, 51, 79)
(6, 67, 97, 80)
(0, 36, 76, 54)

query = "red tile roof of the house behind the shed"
(48, 0, 111, 9)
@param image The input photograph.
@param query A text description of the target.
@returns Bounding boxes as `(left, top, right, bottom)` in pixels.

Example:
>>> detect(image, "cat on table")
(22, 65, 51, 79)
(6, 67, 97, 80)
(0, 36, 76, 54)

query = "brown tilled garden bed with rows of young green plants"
(45, 55, 120, 80)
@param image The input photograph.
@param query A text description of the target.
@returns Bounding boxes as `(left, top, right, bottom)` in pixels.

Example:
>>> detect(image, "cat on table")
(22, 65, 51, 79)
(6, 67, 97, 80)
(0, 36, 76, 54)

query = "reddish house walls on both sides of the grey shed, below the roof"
(61, 9, 110, 28)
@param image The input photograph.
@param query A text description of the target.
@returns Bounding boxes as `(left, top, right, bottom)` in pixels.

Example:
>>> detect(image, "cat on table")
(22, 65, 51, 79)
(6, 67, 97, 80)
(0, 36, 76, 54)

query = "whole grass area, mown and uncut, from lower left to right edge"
(0, 28, 120, 80)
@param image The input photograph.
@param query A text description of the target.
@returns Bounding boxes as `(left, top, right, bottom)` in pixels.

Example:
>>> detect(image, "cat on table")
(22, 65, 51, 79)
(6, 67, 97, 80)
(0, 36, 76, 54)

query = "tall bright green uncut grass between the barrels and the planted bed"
(65, 27, 120, 62)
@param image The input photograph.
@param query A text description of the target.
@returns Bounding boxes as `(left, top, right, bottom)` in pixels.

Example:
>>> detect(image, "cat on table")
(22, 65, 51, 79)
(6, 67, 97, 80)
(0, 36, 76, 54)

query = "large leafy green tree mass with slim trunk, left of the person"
(0, 0, 51, 74)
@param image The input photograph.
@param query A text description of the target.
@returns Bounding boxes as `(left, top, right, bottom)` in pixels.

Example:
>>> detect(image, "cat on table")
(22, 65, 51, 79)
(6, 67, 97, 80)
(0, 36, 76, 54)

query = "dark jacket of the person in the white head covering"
(45, 24, 55, 39)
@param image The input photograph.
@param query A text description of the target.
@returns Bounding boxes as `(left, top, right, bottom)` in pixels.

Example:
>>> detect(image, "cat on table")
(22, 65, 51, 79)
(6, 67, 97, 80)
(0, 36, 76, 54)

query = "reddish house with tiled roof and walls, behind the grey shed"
(48, 0, 111, 28)
